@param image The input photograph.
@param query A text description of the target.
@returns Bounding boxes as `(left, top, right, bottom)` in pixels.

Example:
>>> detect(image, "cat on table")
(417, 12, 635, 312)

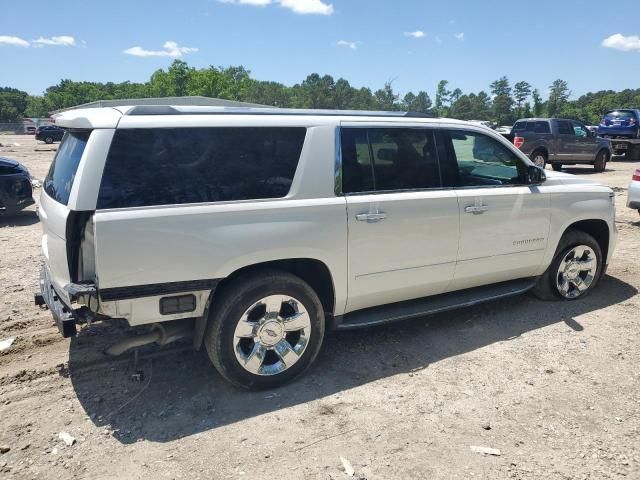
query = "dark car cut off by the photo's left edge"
(0, 157, 34, 216)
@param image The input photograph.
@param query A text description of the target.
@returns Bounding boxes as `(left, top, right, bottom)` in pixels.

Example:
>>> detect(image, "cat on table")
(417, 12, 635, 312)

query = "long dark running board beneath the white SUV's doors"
(336, 278, 537, 330)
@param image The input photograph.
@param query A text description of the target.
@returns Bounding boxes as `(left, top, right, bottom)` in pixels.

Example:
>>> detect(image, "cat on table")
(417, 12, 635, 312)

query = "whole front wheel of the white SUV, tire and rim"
(532, 230, 603, 300)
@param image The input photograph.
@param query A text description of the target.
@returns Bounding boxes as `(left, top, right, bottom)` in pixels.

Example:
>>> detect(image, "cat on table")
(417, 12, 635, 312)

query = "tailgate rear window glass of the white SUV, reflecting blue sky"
(44, 132, 90, 205)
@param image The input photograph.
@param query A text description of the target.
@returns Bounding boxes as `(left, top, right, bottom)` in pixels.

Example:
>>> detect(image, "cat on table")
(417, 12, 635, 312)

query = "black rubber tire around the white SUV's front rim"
(531, 229, 603, 300)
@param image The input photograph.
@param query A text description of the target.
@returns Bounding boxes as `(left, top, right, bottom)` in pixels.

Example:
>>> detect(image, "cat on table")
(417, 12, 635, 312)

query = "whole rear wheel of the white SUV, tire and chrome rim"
(205, 270, 325, 389)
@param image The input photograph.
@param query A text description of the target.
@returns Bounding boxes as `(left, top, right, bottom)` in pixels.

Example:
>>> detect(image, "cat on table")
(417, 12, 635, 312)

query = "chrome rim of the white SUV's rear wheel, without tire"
(233, 295, 311, 376)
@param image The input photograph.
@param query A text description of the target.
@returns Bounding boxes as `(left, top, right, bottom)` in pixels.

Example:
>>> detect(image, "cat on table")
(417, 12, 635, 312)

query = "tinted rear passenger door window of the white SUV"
(341, 128, 441, 193)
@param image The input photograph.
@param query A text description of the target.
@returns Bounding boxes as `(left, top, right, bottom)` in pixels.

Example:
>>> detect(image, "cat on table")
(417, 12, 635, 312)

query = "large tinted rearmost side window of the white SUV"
(97, 127, 306, 209)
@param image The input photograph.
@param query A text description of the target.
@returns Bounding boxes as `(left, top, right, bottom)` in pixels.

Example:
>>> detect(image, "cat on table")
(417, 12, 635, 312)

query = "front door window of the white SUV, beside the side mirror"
(445, 130, 526, 187)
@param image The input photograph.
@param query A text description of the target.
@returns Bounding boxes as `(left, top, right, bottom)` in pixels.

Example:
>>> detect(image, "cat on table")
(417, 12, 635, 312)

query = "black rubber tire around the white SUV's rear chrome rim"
(204, 269, 325, 389)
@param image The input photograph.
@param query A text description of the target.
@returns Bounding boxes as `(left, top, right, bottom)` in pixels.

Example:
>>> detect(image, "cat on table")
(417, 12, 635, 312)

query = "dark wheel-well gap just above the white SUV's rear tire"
(216, 258, 335, 315)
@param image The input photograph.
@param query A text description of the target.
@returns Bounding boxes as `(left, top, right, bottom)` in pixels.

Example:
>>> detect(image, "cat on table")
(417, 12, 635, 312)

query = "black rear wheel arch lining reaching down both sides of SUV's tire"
(193, 258, 336, 350)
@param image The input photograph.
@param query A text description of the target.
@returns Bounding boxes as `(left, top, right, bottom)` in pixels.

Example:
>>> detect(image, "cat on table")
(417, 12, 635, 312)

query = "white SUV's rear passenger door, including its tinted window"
(341, 125, 459, 312)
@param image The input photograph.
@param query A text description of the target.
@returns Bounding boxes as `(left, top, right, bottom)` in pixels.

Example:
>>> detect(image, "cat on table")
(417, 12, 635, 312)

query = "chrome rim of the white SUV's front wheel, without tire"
(556, 245, 598, 298)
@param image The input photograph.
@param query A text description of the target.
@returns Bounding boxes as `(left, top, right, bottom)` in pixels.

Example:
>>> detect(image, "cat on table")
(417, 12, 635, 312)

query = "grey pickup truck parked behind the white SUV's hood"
(511, 118, 611, 172)
